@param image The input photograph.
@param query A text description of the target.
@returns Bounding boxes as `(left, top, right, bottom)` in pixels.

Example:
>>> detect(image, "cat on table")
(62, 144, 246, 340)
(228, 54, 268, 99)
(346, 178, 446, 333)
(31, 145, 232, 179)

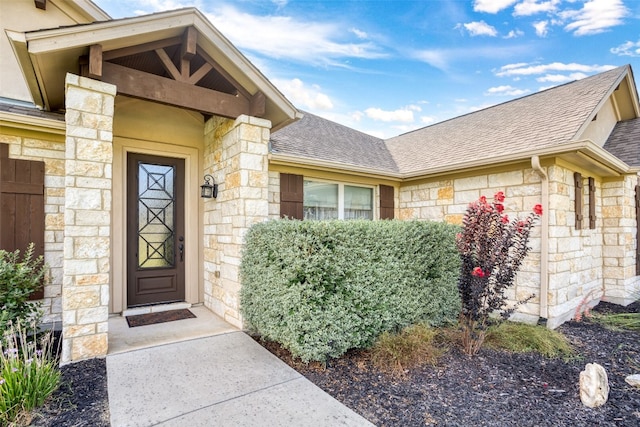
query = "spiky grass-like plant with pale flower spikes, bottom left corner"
(0, 321, 60, 425)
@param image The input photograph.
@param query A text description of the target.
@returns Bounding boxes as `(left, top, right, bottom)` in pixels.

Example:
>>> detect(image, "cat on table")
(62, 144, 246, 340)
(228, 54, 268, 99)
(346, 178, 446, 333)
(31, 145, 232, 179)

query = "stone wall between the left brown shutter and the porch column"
(0, 130, 65, 324)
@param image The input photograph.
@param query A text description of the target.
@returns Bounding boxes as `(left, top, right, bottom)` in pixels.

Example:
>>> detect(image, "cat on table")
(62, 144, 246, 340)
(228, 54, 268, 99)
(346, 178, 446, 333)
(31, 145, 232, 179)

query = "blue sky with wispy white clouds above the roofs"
(94, 0, 640, 138)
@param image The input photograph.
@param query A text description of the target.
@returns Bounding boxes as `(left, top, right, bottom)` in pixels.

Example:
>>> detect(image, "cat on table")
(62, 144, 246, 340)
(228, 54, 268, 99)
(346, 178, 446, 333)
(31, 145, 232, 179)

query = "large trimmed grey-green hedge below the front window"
(240, 220, 460, 362)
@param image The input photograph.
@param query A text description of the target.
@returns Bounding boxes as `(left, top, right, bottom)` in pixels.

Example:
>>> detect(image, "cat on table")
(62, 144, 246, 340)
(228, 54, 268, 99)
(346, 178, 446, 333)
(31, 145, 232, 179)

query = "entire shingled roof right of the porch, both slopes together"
(271, 65, 640, 177)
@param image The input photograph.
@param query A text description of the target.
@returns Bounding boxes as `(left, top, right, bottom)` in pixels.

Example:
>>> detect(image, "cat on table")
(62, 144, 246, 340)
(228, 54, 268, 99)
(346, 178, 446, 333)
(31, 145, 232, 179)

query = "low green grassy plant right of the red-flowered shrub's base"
(485, 322, 574, 359)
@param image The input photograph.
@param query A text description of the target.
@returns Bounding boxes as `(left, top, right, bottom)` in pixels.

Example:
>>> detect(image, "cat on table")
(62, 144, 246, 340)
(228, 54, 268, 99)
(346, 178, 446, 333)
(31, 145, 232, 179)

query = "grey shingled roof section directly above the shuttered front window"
(271, 112, 398, 172)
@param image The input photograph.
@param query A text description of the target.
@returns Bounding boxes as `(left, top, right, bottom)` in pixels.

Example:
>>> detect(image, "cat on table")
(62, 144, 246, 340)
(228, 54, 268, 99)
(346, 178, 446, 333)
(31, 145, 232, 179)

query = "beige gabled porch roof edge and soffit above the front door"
(7, 8, 299, 129)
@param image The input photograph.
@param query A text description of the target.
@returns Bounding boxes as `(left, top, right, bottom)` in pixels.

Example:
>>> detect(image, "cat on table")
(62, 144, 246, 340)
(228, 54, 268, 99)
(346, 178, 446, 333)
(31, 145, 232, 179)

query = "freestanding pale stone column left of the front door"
(61, 74, 116, 364)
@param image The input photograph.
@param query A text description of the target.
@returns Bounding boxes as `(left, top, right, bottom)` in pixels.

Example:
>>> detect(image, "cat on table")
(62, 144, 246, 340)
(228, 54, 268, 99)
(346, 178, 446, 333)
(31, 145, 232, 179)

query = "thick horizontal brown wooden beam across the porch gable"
(102, 62, 251, 119)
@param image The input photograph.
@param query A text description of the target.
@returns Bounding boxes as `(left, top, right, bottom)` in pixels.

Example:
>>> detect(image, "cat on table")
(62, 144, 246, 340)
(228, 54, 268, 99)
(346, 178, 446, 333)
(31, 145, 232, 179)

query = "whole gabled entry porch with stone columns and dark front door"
(12, 9, 299, 363)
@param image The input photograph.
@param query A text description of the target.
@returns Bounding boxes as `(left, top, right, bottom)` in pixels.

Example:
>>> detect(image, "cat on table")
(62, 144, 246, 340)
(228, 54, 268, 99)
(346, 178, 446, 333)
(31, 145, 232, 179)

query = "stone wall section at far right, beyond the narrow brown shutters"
(602, 175, 640, 305)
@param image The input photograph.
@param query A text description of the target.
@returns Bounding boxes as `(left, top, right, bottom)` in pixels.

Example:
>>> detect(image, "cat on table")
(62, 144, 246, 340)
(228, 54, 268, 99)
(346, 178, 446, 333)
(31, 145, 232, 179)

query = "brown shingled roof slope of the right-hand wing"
(387, 66, 630, 175)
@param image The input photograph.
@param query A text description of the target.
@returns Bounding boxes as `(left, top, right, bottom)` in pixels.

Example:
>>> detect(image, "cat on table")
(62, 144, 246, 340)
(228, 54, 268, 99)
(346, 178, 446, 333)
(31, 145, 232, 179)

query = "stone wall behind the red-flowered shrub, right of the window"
(398, 169, 548, 322)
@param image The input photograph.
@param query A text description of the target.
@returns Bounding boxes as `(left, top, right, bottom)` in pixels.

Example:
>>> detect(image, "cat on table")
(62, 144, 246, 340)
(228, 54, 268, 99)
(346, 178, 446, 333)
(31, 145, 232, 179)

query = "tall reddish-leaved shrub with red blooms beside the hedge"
(456, 191, 542, 355)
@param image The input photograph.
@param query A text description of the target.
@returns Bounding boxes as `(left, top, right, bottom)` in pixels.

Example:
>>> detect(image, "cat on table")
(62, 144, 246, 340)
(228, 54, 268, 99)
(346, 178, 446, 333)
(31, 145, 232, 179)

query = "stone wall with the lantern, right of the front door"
(204, 116, 271, 327)
